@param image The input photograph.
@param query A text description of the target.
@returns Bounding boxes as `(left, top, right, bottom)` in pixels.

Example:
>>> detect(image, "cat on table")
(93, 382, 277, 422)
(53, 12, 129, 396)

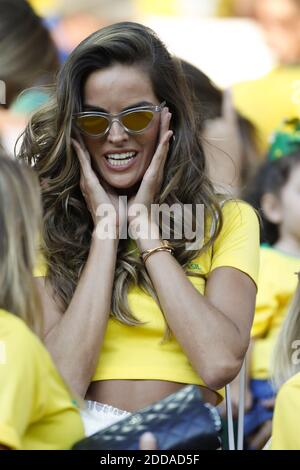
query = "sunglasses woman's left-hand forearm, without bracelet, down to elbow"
(45, 236, 117, 396)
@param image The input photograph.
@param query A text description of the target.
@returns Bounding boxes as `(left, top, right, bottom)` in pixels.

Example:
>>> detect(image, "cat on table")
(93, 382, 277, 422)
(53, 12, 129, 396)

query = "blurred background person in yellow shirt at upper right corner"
(232, 0, 300, 159)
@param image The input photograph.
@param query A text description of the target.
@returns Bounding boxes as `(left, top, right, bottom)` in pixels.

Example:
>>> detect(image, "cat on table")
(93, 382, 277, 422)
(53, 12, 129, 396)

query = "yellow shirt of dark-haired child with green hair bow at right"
(250, 246, 300, 379)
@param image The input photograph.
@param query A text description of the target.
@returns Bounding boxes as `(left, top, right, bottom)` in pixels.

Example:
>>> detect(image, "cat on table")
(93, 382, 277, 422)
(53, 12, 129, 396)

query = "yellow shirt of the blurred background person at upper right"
(232, 65, 300, 153)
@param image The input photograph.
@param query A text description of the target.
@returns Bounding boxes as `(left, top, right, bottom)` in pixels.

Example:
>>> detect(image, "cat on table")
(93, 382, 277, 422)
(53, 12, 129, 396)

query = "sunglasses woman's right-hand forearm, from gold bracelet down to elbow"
(139, 233, 254, 388)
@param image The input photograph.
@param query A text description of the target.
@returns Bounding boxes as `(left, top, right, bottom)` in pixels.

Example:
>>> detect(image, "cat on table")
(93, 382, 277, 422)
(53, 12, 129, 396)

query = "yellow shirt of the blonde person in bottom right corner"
(271, 373, 300, 450)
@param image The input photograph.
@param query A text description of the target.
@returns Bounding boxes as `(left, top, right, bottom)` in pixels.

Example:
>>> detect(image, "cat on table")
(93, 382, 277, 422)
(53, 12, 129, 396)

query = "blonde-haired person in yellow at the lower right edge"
(270, 273, 300, 450)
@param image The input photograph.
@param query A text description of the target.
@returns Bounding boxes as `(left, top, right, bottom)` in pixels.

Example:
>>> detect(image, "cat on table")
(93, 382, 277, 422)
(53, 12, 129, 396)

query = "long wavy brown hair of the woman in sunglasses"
(19, 22, 222, 325)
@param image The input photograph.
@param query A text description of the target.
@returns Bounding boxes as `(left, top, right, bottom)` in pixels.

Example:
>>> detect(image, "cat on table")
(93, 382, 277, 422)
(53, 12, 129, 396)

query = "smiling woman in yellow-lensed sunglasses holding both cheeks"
(19, 22, 259, 430)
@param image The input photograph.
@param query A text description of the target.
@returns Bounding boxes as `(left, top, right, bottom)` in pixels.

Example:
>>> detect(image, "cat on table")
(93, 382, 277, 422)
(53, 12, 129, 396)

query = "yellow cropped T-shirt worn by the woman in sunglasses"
(36, 201, 259, 398)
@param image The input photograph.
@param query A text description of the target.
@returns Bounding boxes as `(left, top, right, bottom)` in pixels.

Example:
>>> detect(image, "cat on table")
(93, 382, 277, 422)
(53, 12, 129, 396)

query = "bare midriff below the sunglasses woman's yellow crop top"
(85, 380, 218, 412)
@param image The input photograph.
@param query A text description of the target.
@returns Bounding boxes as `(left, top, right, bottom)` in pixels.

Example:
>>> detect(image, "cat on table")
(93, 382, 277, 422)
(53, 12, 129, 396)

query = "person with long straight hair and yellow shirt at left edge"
(0, 155, 84, 450)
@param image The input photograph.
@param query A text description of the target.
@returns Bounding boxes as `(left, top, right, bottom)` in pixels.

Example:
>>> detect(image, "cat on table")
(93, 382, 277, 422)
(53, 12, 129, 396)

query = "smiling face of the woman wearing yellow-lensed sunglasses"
(83, 64, 160, 193)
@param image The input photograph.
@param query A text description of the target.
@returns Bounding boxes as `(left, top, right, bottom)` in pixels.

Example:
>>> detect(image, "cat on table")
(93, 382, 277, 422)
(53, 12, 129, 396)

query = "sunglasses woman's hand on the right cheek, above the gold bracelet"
(128, 108, 173, 231)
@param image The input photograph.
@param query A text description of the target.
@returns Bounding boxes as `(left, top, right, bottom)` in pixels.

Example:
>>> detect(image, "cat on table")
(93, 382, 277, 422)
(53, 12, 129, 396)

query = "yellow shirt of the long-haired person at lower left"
(0, 310, 84, 450)
